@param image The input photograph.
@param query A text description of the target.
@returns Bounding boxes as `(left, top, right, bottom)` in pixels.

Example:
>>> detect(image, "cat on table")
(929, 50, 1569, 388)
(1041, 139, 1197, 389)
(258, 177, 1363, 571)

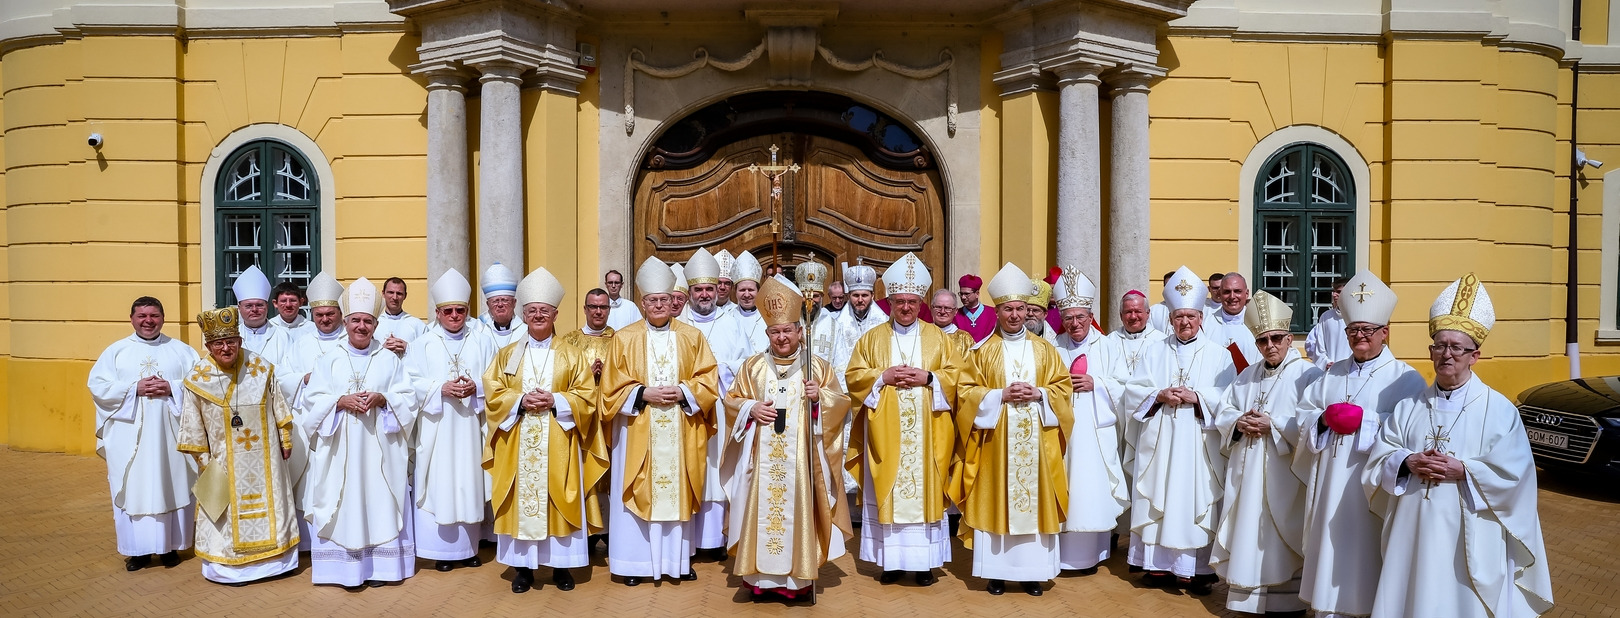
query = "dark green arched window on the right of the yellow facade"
(1254, 143, 1356, 333)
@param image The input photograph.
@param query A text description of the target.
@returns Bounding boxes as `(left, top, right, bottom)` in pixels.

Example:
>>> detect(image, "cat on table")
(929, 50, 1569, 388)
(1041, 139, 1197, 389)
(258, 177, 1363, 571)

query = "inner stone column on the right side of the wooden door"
(1053, 63, 1103, 279)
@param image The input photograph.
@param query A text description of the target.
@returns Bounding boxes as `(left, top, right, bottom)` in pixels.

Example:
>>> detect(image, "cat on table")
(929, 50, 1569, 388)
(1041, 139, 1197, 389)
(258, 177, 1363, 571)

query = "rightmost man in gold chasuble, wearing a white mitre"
(949, 263, 1074, 597)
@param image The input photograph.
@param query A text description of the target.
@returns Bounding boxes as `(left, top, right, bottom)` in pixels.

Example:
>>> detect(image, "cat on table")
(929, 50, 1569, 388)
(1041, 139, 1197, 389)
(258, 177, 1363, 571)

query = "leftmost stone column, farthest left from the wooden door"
(428, 68, 478, 284)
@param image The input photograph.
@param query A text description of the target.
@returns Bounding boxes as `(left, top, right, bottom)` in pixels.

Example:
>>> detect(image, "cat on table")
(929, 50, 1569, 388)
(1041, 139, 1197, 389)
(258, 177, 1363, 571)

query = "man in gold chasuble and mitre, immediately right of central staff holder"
(844, 253, 966, 586)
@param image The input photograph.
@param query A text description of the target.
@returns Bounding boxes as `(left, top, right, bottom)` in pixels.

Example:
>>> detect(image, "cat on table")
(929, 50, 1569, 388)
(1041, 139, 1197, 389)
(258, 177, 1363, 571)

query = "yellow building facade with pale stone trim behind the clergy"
(0, 0, 1620, 454)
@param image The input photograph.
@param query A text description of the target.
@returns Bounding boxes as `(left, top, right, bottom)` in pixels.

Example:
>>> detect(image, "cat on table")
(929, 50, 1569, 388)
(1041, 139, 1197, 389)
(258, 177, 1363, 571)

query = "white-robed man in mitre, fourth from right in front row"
(1124, 266, 1254, 595)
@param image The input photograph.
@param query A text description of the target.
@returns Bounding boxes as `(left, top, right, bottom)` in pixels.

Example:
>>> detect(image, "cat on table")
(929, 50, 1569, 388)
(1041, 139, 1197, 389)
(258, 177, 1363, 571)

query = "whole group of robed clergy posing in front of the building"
(89, 250, 1552, 616)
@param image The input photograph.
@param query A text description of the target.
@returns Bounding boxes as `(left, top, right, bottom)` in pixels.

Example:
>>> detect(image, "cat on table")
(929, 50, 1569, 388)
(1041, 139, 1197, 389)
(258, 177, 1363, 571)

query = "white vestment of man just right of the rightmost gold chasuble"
(1056, 328, 1142, 569)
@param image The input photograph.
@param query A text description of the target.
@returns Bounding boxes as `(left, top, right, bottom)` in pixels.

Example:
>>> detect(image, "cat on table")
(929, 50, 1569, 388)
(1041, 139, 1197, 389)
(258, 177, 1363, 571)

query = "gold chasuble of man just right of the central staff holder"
(844, 320, 962, 524)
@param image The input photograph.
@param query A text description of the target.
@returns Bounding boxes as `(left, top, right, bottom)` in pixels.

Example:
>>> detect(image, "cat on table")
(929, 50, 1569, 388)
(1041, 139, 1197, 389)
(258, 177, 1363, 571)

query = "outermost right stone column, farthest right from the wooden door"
(1103, 71, 1153, 308)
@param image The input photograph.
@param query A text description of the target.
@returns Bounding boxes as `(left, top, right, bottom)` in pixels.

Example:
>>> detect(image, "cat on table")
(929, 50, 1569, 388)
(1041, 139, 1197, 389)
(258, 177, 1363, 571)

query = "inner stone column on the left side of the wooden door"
(476, 62, 528, 276)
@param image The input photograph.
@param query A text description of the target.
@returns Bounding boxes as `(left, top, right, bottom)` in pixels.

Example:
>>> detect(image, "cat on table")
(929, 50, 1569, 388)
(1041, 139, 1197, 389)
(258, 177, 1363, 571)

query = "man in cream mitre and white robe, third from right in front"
(1210, 290, 1322, 613)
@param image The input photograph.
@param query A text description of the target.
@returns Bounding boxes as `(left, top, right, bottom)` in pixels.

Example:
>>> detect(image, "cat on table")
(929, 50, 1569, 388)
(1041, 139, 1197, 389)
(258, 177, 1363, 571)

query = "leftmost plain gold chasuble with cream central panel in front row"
(484, 336, 608, 540)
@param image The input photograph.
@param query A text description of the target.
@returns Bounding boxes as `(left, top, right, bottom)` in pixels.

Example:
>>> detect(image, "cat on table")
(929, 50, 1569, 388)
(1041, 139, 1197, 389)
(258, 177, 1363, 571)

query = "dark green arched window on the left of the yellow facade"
(214, 139, 321, 307)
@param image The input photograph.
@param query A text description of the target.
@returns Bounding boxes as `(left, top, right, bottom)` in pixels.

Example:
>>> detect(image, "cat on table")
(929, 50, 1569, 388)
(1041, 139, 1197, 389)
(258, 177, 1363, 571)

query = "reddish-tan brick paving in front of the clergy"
(0, 448, 1620, 618)
